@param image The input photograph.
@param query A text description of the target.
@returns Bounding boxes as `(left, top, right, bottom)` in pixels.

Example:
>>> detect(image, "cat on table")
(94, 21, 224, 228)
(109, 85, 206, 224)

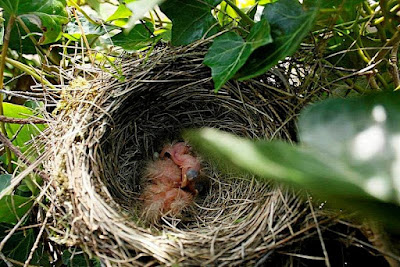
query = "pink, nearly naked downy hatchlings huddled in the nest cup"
(141, 142, 200, 222)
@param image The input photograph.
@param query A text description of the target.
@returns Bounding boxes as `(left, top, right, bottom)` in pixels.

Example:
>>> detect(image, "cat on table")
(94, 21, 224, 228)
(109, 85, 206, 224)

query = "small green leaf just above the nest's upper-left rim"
(111, 22, 154, 51)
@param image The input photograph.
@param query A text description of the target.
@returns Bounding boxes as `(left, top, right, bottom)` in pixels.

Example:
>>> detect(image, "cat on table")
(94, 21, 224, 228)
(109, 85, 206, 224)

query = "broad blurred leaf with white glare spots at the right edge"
(299, 93, 400, 204)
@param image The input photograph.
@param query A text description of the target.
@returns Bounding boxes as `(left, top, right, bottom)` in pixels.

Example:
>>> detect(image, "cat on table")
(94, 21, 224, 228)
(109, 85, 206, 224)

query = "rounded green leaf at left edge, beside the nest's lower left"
(0, 195, 33, 224)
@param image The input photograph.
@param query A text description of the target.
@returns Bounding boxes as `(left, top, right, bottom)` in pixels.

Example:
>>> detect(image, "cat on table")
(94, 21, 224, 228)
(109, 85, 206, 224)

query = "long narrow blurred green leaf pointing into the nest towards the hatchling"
(185, 128, 400, 231)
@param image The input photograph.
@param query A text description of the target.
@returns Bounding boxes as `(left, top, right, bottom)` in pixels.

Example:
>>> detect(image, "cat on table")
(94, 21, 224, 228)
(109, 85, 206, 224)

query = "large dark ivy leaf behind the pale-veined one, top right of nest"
(237, 0, 317, 80)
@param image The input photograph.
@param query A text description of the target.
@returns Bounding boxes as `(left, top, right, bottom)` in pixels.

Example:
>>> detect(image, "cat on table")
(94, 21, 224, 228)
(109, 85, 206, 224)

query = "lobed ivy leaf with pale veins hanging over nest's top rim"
(203, 19, 272, 92)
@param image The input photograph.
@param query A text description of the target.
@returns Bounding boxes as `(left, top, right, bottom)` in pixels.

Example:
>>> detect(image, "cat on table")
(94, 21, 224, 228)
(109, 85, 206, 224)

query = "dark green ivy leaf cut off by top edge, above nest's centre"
(160, 0, 221, 45)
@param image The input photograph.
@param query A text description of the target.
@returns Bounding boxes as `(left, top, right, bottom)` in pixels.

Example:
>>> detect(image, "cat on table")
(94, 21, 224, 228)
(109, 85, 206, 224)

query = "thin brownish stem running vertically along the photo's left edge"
(0, 15, 15, 173)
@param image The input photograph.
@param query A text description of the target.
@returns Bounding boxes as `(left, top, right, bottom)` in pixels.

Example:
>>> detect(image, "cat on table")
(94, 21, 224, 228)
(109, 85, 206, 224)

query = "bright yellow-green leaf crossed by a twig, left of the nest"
(3, 103, 45, 152)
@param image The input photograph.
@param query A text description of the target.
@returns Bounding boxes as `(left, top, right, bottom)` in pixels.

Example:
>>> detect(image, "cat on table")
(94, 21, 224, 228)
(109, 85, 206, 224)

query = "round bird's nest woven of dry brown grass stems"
(44, 43, 324, 266)
